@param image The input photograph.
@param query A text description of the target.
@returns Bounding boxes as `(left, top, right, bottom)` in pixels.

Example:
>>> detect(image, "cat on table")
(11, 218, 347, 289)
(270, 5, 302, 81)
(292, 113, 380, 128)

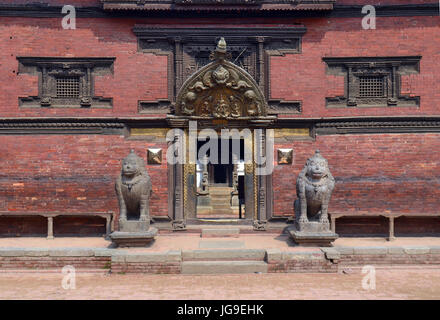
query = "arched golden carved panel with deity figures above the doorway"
(176, 38, 267, 119)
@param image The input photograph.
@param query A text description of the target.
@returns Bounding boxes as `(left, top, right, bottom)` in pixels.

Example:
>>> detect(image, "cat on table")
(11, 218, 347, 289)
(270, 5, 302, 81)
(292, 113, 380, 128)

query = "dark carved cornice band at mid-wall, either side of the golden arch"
(0, 116, 440, 136)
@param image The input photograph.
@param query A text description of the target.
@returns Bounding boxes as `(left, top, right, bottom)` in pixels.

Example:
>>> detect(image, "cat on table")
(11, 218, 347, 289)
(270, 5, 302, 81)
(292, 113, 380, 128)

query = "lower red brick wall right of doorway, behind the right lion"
(273, 133, 440, 215)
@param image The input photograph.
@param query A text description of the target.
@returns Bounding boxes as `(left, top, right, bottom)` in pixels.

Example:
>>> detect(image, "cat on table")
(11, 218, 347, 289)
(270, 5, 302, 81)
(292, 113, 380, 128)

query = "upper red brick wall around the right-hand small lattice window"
(271, 16, 440, 117)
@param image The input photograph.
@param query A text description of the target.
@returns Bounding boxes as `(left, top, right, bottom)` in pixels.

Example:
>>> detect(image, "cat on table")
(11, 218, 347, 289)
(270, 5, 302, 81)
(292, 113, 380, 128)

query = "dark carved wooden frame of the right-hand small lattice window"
(323, 56, 421, 108)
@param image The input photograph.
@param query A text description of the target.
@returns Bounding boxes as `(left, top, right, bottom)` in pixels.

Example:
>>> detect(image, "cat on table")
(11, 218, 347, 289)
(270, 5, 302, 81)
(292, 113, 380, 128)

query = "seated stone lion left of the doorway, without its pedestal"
(115, 150, 152, 222)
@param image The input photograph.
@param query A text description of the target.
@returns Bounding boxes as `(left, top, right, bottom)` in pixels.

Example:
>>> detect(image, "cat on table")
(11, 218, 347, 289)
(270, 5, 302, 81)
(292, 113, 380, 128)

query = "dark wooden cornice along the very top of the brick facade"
(0, 0, 439, 18)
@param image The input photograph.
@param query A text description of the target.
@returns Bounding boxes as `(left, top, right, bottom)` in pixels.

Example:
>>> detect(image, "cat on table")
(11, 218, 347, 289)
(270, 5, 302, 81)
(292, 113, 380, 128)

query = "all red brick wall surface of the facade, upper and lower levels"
(0, 10, 440, 235)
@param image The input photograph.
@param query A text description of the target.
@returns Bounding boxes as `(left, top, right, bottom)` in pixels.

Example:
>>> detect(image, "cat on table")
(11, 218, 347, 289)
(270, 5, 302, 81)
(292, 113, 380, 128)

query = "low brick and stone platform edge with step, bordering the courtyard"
(0, 247, 440, 274)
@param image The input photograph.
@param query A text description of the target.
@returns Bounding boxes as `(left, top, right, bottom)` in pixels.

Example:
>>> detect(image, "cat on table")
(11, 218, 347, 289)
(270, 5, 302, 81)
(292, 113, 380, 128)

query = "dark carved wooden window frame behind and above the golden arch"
(133, 25, 306, 114)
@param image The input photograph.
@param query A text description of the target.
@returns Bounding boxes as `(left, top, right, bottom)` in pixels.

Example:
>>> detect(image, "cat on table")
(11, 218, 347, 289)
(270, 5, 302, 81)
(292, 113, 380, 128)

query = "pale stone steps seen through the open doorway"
(197, 186, 239, 219)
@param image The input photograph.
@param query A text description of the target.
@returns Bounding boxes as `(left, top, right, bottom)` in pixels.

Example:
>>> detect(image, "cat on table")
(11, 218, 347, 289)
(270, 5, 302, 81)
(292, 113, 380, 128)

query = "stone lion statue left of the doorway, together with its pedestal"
(110, 150, 157, 247)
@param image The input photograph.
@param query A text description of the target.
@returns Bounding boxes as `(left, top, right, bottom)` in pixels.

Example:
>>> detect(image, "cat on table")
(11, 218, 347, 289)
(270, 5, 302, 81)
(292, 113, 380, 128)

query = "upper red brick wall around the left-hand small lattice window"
(0, 18, 168, 117)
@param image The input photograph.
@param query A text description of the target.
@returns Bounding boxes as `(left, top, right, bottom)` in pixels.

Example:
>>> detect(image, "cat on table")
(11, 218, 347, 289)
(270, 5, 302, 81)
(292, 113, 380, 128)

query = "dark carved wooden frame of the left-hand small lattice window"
(17, 57, 115, 108)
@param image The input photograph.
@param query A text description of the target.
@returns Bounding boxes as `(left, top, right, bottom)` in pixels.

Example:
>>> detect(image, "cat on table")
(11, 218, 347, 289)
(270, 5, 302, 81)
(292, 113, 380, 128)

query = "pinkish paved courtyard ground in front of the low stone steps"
(0, 267, 440, 300)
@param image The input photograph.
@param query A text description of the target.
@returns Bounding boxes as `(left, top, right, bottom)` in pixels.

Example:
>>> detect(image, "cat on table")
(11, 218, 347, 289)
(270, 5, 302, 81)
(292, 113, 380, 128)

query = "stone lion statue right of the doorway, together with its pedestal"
(289, 150, 338, 247)
